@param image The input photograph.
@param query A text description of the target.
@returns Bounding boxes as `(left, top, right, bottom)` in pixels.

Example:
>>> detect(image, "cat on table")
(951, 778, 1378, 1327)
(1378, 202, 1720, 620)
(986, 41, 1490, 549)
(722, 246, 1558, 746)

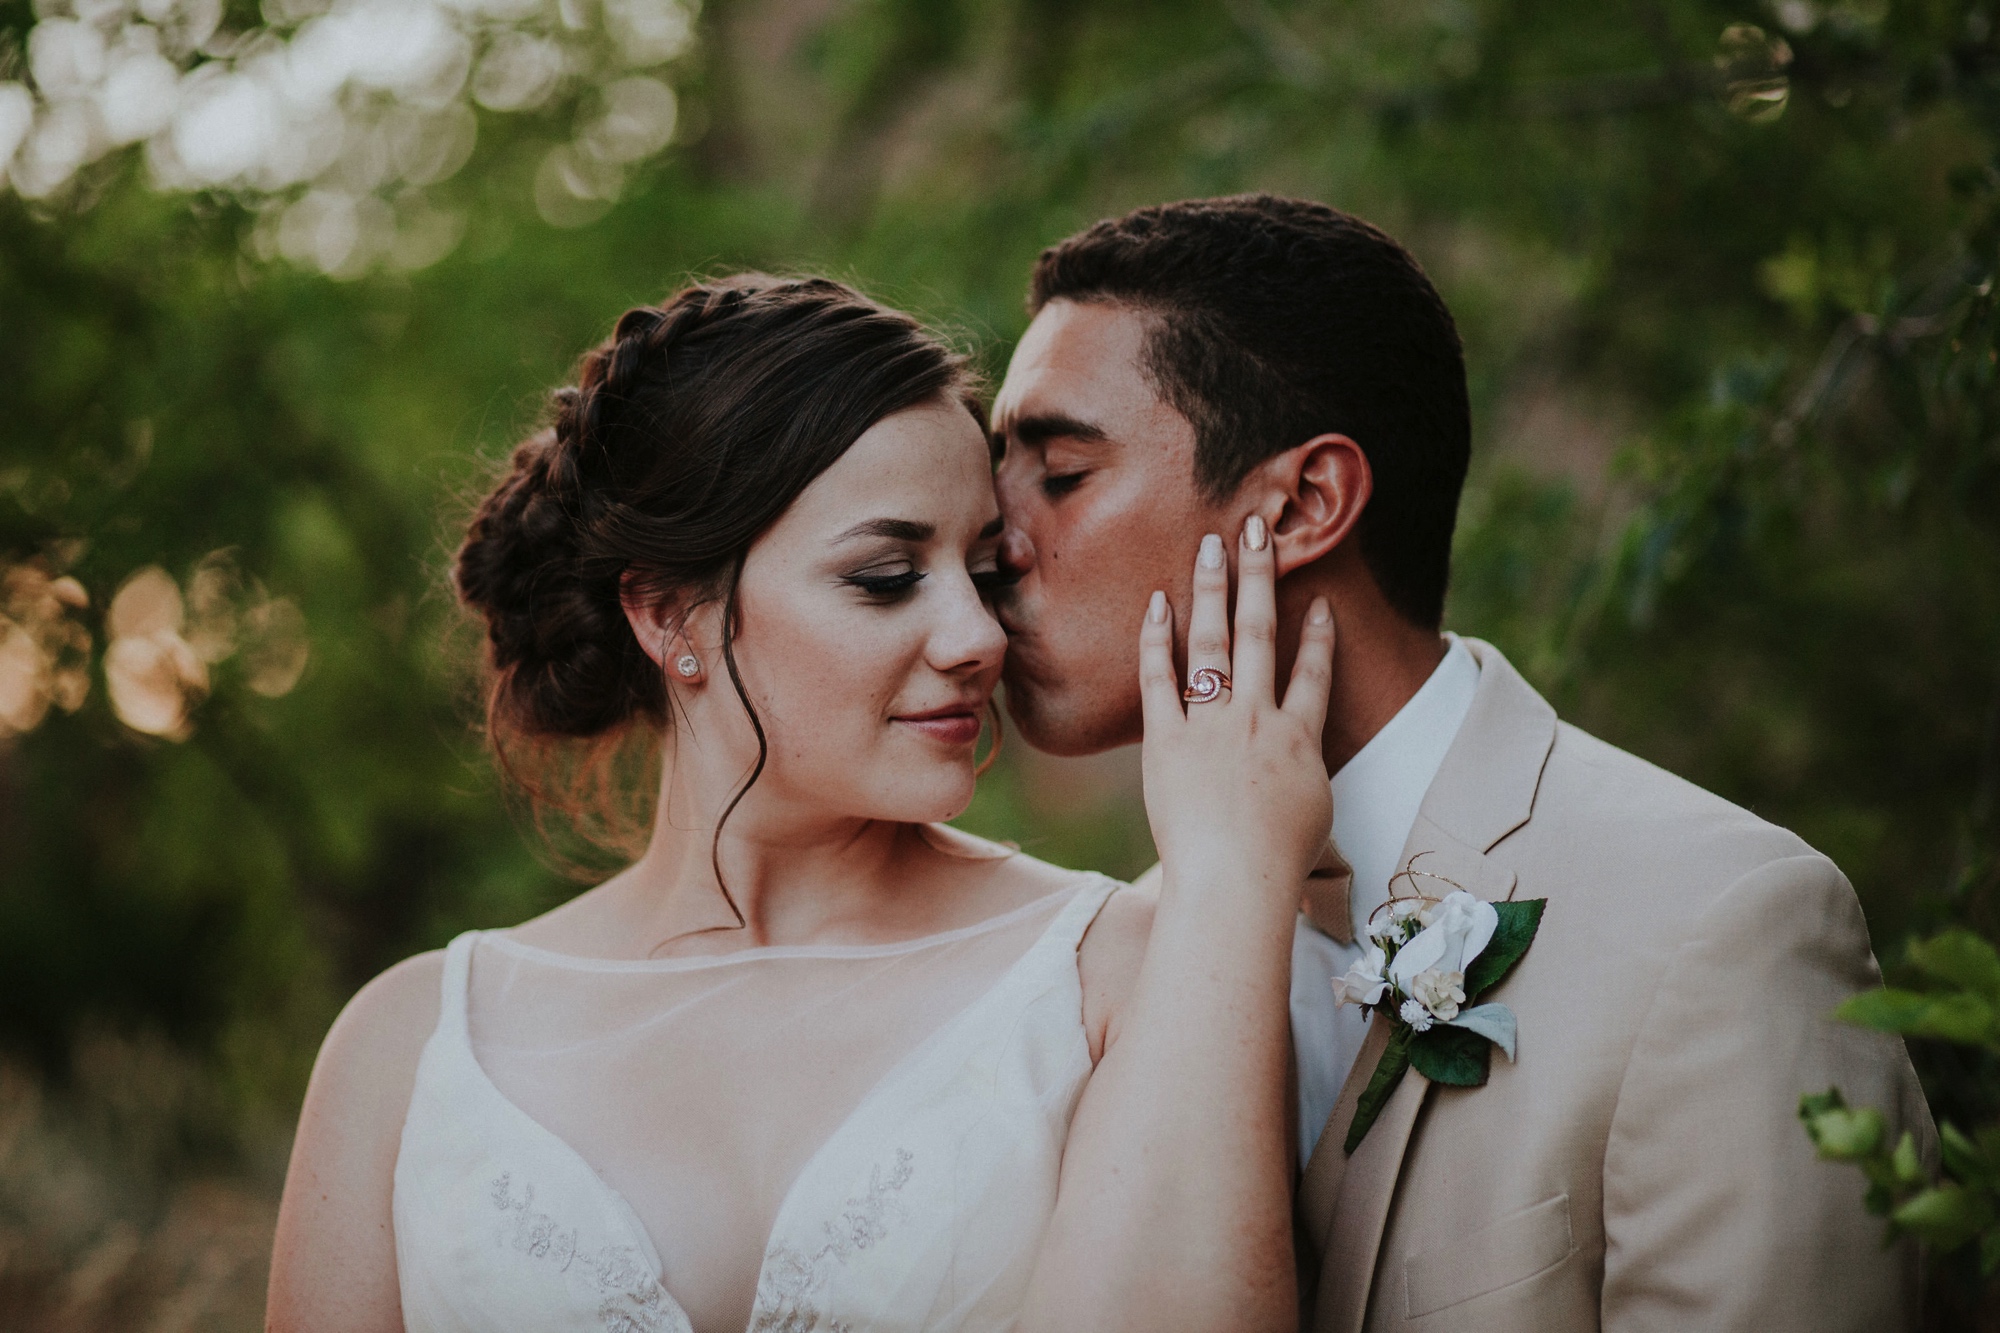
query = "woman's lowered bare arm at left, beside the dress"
(264, 953, 444, 1333)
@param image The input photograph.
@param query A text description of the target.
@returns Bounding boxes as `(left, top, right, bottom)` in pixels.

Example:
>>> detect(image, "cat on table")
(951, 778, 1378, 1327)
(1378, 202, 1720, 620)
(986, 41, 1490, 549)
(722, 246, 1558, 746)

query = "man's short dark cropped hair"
(1028, 194, 1472, 628)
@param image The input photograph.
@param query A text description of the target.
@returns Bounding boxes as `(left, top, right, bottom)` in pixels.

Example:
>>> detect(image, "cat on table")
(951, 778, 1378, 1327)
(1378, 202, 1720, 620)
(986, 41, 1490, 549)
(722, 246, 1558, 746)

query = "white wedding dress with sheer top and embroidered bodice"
(382, 852, 1116, 1333)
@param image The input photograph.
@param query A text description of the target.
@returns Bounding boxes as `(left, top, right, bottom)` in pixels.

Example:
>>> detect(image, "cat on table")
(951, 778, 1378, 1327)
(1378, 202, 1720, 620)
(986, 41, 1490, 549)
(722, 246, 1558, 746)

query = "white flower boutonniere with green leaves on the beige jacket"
(1334, 853, 1548, 1153)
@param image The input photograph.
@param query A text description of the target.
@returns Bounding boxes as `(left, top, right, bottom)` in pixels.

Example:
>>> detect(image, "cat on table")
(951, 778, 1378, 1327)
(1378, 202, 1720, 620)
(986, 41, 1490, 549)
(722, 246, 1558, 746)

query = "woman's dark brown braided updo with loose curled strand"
(452, 274, 980, 868)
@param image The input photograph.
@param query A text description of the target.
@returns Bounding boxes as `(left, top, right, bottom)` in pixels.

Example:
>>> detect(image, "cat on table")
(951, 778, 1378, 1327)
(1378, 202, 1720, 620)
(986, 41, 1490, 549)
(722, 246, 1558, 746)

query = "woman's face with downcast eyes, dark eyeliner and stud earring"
(690, 400, 1006, 821)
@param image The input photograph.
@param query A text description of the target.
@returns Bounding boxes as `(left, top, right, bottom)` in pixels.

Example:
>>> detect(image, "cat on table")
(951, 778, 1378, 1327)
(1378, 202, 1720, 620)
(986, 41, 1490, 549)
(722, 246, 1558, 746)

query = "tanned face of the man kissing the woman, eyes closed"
(994, 300, 1234, 755)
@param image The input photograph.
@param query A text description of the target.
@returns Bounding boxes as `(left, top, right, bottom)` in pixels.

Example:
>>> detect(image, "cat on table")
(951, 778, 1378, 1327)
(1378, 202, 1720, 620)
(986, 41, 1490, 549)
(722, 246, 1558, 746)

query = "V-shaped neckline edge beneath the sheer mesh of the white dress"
(436, 875, 1100, 1333)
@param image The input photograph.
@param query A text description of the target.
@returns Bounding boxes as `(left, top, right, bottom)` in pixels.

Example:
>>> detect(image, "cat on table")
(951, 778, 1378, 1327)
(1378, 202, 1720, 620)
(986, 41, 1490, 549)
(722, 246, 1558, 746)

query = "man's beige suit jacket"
(1298, 638, 1936, 1333)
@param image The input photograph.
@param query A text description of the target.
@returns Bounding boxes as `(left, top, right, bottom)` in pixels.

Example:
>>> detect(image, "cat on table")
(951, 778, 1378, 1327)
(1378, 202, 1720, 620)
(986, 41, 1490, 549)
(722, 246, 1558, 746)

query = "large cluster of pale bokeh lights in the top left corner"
(0, 0, 692, 278)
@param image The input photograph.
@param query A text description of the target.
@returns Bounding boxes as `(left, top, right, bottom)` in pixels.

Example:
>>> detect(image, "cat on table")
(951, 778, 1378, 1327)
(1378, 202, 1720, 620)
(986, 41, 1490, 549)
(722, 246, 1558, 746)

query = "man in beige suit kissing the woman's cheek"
(994, 196, 1934, 1333)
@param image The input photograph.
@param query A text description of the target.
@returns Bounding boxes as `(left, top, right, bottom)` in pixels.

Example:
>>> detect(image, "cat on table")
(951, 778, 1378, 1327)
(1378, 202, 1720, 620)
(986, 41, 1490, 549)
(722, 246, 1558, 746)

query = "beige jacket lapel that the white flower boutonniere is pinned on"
(1298, 638, 1556, 1333)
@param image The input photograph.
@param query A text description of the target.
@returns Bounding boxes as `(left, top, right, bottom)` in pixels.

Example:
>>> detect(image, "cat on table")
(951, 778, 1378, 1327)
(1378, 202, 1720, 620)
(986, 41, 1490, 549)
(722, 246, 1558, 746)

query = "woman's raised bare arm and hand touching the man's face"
(1020, 516, 1334, 1333)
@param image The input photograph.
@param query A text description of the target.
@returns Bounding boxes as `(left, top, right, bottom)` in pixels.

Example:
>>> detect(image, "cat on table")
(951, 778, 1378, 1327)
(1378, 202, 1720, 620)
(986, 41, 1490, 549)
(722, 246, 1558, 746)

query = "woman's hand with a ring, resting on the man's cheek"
(1140, 514, 1334, 896)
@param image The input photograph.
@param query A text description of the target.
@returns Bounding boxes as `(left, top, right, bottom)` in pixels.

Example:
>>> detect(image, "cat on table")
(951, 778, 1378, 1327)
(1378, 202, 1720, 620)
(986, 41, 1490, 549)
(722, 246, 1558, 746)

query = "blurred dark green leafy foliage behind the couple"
(0, 0, 2000, 1331)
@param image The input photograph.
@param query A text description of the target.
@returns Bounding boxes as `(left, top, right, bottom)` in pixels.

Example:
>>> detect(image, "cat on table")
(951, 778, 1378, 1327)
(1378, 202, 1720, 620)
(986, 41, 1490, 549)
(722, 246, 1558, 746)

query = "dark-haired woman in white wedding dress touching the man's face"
(268, 274, 1332, 1333)
